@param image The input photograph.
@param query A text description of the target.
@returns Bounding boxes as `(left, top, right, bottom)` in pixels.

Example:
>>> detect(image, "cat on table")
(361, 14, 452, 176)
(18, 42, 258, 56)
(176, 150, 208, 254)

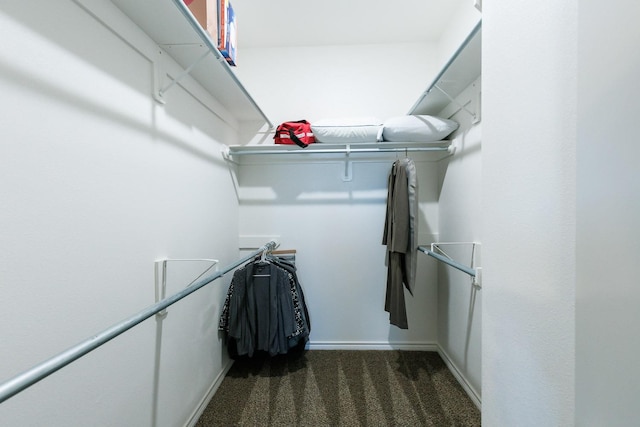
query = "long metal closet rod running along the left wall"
(0, 240, 278, 403)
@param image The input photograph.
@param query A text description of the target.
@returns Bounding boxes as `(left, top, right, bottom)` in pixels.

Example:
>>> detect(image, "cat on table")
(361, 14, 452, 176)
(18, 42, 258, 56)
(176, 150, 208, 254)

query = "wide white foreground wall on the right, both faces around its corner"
(483, 1, 640, 426)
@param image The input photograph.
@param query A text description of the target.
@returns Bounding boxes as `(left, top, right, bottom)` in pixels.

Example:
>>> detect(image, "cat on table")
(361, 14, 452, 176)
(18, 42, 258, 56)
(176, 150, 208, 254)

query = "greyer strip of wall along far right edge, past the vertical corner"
(576, 0, 640, 426)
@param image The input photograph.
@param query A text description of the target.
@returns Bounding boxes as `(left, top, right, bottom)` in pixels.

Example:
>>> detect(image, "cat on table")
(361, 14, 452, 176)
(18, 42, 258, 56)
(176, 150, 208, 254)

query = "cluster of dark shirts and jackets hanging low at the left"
(218, 257, 311, 357)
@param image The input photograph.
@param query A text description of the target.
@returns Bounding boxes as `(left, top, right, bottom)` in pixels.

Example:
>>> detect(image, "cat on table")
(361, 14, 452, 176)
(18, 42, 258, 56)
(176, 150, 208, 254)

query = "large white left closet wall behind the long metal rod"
(0, 1, 238, 426)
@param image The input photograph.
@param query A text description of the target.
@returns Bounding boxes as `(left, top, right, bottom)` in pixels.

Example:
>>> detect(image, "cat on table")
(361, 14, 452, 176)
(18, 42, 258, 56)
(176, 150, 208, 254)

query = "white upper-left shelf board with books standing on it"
(111, 0, 273, 126)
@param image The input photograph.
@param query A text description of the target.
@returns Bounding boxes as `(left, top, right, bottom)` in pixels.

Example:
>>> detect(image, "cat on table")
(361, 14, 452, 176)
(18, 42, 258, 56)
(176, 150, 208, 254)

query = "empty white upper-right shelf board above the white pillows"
(409, 22, 482, 115)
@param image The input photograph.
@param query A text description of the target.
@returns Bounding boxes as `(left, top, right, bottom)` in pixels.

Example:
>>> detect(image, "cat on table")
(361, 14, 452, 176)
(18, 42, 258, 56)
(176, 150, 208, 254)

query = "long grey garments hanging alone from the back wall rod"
(382, 158, 418, 329)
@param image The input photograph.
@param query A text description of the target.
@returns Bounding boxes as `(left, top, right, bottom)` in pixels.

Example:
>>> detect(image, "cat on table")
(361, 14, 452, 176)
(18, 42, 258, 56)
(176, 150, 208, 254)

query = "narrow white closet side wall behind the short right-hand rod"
(432, 78, 483, 404)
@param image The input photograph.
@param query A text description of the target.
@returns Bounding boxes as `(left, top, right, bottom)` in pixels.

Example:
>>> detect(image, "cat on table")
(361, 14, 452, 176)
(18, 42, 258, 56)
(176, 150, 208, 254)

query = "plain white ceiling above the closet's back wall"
(231, 0, 464, 48)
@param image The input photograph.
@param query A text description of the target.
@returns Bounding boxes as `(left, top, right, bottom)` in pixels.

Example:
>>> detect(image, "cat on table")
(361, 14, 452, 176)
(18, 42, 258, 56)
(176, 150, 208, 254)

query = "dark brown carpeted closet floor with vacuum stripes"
(196, 350, 480, 427)
